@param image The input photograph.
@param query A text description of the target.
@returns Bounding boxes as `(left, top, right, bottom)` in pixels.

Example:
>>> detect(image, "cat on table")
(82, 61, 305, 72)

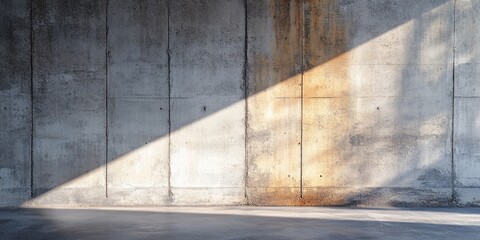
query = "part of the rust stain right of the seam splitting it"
(302, 0, 351, 205)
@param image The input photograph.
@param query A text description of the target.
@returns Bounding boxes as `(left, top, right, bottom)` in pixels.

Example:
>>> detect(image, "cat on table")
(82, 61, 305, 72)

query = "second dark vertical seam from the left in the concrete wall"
(105, 0, 109, 198)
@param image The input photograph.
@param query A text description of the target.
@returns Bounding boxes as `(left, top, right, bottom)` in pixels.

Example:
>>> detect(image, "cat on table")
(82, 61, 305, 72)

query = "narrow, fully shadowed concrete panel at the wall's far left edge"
(0, 0, 31, 205)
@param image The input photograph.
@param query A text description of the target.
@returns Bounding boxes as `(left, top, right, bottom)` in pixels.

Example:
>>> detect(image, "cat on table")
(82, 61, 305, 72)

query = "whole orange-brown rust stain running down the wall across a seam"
(247, 0, 350, 205)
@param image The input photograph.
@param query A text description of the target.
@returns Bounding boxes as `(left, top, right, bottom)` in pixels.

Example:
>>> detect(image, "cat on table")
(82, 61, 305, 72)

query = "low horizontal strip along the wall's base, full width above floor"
(0, 187, 480, 207)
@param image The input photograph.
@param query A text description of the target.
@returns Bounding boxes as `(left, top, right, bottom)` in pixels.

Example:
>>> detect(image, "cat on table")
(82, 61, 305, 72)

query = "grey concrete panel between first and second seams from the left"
(32, 0, 106, 205)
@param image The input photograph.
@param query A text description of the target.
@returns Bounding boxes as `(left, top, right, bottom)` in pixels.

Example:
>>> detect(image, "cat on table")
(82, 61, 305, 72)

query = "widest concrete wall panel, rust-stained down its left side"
(302, 1, 453, 206)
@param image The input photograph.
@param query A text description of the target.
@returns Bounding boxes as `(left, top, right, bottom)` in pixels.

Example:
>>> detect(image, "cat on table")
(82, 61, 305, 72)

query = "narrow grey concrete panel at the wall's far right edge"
(454, 1, 480, 206)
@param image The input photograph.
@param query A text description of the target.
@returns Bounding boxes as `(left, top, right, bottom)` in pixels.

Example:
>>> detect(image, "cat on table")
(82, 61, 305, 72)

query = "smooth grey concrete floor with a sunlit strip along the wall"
(0, 207, 480, 239)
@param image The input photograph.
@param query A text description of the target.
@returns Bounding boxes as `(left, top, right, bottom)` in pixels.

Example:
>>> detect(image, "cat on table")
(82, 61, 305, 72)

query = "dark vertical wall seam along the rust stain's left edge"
(243, 0, 248, 203)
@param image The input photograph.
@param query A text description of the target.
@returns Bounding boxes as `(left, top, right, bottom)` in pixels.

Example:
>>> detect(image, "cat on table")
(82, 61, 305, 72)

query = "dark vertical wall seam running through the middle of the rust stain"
(300, 0, 305, 198)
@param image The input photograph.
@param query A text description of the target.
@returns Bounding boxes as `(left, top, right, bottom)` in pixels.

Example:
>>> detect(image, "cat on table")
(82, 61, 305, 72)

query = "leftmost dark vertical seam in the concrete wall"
(30, 0, 34, 198)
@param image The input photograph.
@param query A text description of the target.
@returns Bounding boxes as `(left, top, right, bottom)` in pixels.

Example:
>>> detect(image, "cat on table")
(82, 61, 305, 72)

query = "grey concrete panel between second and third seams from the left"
(107, 0, 169, 205)
